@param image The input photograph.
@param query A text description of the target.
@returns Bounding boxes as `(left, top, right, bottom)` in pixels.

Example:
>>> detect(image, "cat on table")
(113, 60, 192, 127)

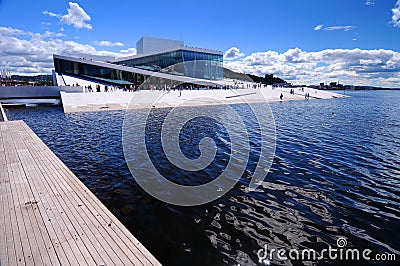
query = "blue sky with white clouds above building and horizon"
(0, 0, 400, 88)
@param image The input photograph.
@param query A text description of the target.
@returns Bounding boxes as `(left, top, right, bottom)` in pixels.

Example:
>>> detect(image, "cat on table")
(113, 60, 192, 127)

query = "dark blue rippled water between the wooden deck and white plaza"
(6, 91, 400, 265)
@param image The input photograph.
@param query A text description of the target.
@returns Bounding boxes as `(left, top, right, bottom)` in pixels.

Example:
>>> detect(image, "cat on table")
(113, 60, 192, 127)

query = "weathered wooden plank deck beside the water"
(0, 121, 160, 266)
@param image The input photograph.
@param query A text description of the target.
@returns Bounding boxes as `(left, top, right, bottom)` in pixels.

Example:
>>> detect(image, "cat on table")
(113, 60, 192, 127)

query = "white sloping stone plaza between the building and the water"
(61, 87, 347, 113)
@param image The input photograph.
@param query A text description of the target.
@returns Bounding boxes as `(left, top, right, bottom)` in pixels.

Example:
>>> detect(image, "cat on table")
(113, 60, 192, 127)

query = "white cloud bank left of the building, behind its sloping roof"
(0, 27, 136, 75)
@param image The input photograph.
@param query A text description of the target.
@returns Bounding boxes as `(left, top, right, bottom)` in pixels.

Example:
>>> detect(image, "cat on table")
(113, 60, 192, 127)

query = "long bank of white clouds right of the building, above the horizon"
(224, 48, 400, 87)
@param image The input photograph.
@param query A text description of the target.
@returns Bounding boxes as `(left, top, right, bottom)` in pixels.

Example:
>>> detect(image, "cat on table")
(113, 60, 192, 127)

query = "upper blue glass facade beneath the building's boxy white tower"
(117, 49, 224, 80)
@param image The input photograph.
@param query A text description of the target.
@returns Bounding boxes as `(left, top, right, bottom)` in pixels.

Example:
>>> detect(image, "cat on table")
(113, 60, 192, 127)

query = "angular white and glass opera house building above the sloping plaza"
(53, 37, 224, 87)
